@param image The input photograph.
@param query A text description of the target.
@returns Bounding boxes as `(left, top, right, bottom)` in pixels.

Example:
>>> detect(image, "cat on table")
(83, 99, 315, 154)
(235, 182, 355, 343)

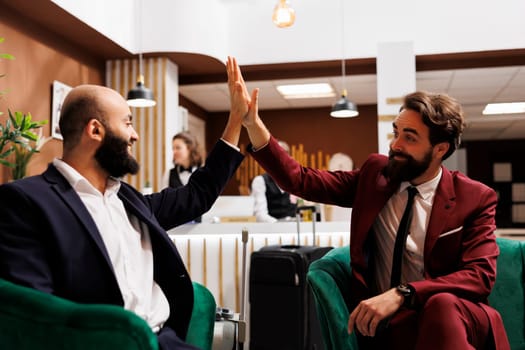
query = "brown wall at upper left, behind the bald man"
(0, 8, 105, 183)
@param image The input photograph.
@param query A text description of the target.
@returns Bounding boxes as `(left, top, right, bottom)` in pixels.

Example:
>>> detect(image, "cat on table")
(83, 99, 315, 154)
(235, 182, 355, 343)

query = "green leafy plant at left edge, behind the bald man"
(0, 38, 47, 180)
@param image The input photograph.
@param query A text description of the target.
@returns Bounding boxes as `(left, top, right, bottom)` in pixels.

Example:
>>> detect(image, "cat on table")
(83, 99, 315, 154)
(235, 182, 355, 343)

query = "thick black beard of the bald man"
(95, 128, 140, 178)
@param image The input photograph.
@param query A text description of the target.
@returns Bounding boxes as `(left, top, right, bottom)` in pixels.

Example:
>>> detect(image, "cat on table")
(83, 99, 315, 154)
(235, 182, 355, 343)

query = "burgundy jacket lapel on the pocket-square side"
(424, 167, 456, 265)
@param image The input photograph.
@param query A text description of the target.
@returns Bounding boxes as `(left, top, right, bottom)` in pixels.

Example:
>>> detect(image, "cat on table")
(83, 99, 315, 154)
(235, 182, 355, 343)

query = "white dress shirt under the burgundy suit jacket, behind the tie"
(372, 169, 442, 293)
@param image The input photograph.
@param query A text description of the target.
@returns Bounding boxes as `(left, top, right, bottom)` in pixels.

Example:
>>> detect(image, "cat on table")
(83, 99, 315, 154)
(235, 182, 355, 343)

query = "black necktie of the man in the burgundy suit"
(390, 186, 417, 287)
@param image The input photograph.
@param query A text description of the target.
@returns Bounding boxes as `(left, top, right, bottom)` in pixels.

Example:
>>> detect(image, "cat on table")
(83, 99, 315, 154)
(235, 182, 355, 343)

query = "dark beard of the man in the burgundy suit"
(385, 148, 432, 183)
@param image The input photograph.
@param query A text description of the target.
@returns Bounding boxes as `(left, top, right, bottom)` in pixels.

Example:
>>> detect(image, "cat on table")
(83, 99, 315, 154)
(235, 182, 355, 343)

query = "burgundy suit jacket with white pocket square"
(249, 137, 509, 349)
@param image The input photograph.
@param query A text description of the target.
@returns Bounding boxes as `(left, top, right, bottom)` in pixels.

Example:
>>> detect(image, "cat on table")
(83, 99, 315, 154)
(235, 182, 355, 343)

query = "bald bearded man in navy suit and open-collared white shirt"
(0, 85, 243, 350)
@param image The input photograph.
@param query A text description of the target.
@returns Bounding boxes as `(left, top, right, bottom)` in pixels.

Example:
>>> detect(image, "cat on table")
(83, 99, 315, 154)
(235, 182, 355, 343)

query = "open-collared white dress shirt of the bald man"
(53, 159, 170, 331)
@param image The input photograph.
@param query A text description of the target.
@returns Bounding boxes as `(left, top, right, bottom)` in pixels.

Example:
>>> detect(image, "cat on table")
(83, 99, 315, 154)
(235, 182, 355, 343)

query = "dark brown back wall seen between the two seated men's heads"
(206, 105, 377, 195)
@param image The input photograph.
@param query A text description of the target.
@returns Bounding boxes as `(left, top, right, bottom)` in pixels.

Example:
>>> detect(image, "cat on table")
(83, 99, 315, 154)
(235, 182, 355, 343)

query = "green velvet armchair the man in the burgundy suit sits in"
(307, 238, 525, 350)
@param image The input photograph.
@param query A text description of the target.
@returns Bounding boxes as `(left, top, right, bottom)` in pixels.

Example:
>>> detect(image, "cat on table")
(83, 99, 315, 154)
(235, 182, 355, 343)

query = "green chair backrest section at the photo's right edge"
(489, 238, 525, 349)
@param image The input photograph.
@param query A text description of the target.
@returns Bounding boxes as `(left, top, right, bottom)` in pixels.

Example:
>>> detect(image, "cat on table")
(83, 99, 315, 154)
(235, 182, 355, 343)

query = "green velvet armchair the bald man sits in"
(0, 279, 216, 350)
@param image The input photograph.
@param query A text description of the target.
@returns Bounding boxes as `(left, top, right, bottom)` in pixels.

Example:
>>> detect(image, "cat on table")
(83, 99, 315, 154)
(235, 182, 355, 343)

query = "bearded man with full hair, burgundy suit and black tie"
(228, 59, 509, 350)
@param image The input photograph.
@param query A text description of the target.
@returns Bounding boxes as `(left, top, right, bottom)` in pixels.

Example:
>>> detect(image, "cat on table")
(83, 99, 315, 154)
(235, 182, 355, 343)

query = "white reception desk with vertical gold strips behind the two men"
(168, 221, 350, 312)
